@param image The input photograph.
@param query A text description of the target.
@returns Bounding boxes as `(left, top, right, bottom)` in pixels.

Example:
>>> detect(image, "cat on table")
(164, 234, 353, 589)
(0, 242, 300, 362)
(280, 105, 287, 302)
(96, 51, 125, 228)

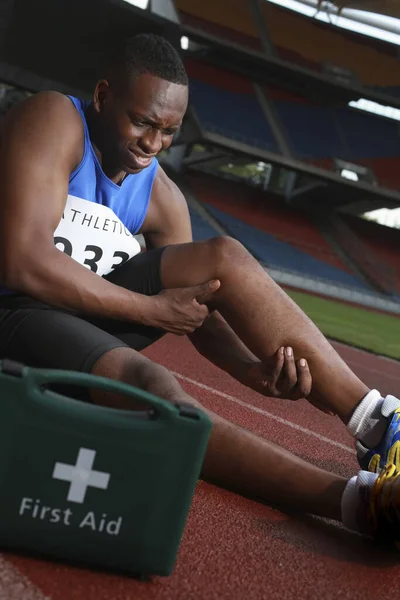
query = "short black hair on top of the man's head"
(107, 33, 189, 86)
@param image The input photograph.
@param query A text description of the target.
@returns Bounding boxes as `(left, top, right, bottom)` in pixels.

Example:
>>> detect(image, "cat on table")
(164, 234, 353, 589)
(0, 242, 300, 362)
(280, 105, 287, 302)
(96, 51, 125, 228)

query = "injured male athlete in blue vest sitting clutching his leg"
(0, 35, 400, 540)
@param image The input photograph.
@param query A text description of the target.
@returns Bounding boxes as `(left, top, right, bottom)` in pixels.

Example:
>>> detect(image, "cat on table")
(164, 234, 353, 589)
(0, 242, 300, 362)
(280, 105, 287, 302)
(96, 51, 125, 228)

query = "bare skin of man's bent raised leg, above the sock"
(161, 237, 369, 423)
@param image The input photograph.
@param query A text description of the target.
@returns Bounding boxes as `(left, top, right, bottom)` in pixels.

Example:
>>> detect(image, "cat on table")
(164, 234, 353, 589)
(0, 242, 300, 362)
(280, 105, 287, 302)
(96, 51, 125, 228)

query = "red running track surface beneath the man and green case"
(0, 336, 400, 600)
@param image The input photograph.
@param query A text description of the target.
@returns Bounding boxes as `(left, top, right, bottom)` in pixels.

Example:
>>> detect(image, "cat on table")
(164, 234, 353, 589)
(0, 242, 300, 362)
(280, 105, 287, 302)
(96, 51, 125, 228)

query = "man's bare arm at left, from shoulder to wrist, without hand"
(0, 92, 161, 322)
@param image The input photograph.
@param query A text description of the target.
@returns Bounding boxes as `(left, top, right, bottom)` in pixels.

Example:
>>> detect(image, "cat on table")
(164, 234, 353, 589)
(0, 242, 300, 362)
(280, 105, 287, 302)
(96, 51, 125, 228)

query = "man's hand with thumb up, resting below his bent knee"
(142, 280, 221, 335)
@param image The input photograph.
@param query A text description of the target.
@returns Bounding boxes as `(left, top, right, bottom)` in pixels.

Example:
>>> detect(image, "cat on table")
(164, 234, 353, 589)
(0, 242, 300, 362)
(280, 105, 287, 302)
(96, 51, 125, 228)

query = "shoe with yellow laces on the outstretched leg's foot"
(370, 464, 400, 540)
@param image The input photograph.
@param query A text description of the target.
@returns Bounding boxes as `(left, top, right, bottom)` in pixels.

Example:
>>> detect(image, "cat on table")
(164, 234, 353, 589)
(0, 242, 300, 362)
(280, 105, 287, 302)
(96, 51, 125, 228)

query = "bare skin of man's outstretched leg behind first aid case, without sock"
(91, 348, 347, 520)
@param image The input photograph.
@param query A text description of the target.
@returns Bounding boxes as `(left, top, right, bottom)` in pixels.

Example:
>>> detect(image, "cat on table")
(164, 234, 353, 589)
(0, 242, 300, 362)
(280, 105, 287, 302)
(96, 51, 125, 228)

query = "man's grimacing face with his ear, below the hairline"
(94, 74, 188, 173)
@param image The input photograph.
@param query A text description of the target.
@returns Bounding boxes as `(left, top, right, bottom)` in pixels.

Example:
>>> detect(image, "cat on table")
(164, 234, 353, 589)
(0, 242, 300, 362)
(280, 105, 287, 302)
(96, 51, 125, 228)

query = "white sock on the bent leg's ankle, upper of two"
(347, 390, 387, 448)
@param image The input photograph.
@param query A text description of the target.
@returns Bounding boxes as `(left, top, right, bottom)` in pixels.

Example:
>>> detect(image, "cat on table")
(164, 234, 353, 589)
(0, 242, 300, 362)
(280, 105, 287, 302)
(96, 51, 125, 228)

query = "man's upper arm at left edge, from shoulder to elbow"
(0, 94, 80, 257)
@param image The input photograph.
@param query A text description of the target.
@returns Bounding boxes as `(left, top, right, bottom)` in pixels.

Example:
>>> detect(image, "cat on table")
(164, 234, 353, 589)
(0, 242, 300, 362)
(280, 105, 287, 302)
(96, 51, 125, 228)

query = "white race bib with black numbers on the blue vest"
(54, 196, 140, 275)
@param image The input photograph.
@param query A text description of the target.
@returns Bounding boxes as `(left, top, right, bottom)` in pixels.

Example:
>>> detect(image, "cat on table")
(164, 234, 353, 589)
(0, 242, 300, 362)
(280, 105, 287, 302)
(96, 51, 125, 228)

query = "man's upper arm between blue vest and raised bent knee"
(141, 171, 193, 250)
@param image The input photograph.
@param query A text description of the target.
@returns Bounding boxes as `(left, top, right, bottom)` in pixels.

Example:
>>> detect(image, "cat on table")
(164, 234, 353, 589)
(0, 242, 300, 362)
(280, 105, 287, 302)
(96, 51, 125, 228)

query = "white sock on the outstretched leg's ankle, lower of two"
(341, 471, 378, 534)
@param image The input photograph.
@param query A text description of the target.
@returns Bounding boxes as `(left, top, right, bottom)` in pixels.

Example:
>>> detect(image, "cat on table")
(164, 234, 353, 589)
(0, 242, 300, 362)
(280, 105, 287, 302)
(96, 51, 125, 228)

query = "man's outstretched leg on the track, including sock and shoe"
(92, 348, 400, 540)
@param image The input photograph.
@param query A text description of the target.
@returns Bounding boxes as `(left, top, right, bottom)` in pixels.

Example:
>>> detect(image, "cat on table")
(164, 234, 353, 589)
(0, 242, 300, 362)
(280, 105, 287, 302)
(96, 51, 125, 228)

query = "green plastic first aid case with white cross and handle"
(0, 360, 211, 576)
